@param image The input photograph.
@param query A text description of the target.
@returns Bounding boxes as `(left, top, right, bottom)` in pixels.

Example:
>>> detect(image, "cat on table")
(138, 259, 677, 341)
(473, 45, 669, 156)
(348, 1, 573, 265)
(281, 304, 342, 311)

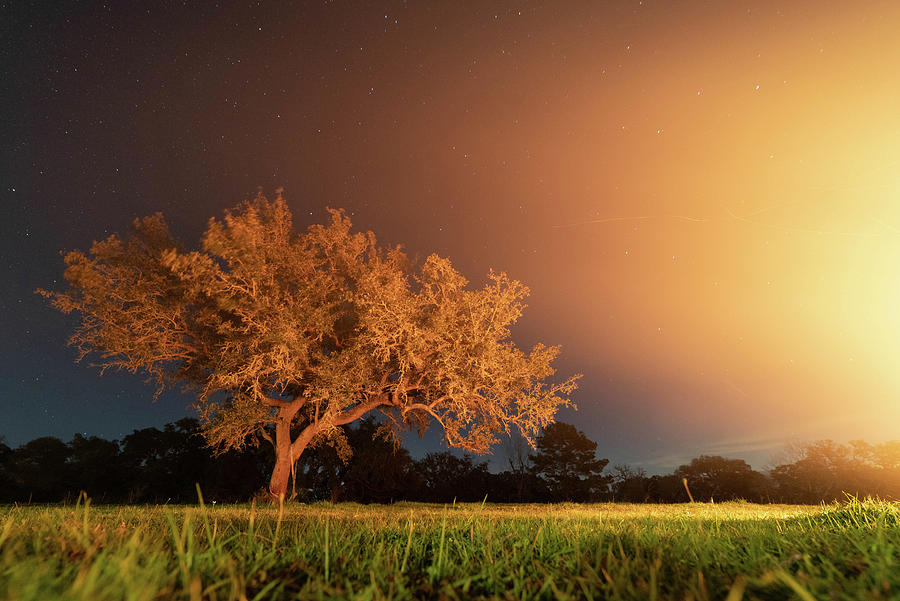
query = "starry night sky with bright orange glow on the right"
(0, 0, 900, 471)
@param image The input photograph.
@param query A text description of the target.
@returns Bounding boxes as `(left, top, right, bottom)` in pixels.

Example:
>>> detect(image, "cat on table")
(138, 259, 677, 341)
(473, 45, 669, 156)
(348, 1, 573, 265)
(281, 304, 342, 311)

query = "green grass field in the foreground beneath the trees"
(0, 494, 900, 601)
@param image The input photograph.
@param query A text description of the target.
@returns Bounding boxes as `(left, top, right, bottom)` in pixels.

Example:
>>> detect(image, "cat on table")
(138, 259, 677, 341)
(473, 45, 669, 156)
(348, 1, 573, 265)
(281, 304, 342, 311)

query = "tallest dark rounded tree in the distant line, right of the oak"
(531, 422, 609, 501)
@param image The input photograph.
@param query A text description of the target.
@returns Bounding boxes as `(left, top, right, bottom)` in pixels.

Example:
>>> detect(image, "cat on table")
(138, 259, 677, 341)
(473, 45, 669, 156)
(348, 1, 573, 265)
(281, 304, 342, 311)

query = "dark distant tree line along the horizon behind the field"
(0, 419, 900, 503)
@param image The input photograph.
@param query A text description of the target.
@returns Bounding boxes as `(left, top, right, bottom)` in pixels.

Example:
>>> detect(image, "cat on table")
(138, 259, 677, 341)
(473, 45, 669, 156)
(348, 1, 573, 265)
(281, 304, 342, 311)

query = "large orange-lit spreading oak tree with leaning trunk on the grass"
(39, 191, 577, 498)
